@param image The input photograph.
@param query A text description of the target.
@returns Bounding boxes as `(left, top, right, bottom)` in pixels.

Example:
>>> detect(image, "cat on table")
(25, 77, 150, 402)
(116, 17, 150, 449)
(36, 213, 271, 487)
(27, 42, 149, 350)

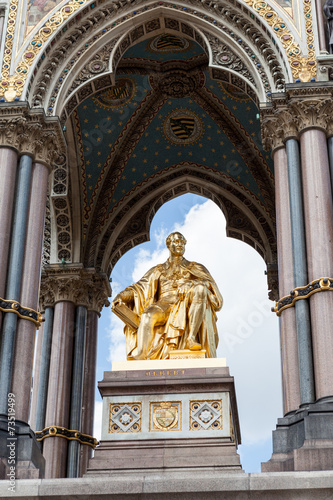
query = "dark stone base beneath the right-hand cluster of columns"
(261, 397, 333, 472)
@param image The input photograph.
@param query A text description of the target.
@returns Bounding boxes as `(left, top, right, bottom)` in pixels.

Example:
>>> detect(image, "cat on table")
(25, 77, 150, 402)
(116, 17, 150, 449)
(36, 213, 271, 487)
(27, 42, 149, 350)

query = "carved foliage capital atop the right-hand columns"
(261, 82, 333, 151)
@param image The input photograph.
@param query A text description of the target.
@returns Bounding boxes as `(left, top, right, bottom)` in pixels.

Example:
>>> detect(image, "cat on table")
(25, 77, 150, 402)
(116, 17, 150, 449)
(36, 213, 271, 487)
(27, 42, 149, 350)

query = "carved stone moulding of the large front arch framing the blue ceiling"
(21, 0, 288, 115)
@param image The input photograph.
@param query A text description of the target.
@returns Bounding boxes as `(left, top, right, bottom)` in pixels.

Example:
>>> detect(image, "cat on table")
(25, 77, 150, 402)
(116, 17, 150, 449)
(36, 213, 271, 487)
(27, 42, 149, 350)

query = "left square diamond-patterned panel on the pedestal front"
(109, 403, 142, 434)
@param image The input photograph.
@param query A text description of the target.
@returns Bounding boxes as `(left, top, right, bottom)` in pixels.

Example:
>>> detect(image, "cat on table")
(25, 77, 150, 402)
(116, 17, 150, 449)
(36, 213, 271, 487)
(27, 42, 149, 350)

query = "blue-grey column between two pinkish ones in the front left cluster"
(0, 155, 32, 414)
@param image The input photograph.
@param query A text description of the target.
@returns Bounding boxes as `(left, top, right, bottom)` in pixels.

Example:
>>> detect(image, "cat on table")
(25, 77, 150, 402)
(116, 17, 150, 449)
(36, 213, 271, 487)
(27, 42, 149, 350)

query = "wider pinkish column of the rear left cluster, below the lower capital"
(43, 301, 75, 478)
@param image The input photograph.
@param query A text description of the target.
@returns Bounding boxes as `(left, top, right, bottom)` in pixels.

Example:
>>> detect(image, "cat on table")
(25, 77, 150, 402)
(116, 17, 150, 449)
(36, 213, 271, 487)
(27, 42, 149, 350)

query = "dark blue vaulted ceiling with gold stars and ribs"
(73, 35, 273, 240)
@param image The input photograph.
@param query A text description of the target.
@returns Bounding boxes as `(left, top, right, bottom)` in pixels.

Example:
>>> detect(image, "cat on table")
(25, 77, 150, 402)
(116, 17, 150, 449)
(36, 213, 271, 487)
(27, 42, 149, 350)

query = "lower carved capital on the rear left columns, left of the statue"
(40, 264, 111, 313)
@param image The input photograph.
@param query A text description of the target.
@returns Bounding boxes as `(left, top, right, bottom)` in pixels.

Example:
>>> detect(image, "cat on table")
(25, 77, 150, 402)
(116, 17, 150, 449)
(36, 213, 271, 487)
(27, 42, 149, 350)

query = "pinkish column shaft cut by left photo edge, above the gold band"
(0, 146, 17, 329)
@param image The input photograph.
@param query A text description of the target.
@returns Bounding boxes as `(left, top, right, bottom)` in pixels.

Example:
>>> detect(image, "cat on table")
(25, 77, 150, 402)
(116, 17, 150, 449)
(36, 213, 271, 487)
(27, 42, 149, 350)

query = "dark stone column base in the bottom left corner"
(0, 414, 45, 480)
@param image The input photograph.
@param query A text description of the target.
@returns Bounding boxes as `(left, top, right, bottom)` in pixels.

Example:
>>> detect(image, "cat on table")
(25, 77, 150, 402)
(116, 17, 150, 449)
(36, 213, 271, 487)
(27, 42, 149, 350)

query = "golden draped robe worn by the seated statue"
(124, 258, 223, 359)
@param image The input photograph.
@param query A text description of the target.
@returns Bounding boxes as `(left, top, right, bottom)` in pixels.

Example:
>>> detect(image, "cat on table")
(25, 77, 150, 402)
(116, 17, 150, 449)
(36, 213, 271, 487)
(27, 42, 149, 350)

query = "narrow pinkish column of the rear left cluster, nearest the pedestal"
(79, 311, 98, 476)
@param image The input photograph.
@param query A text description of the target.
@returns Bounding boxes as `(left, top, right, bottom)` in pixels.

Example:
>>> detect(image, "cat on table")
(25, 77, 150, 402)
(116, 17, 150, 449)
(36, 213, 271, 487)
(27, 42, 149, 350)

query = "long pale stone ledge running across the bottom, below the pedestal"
(0, 470, 333, 500)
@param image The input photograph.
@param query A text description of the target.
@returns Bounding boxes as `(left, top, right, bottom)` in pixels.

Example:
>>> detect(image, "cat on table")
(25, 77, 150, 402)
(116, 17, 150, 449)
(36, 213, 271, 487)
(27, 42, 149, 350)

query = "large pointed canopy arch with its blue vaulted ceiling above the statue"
(26, 2, 280, 298)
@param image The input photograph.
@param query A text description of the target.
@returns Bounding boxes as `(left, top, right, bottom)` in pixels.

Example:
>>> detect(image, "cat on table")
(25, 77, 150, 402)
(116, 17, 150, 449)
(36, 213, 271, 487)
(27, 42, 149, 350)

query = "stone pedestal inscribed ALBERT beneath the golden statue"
(87, 359, 242, 475)
